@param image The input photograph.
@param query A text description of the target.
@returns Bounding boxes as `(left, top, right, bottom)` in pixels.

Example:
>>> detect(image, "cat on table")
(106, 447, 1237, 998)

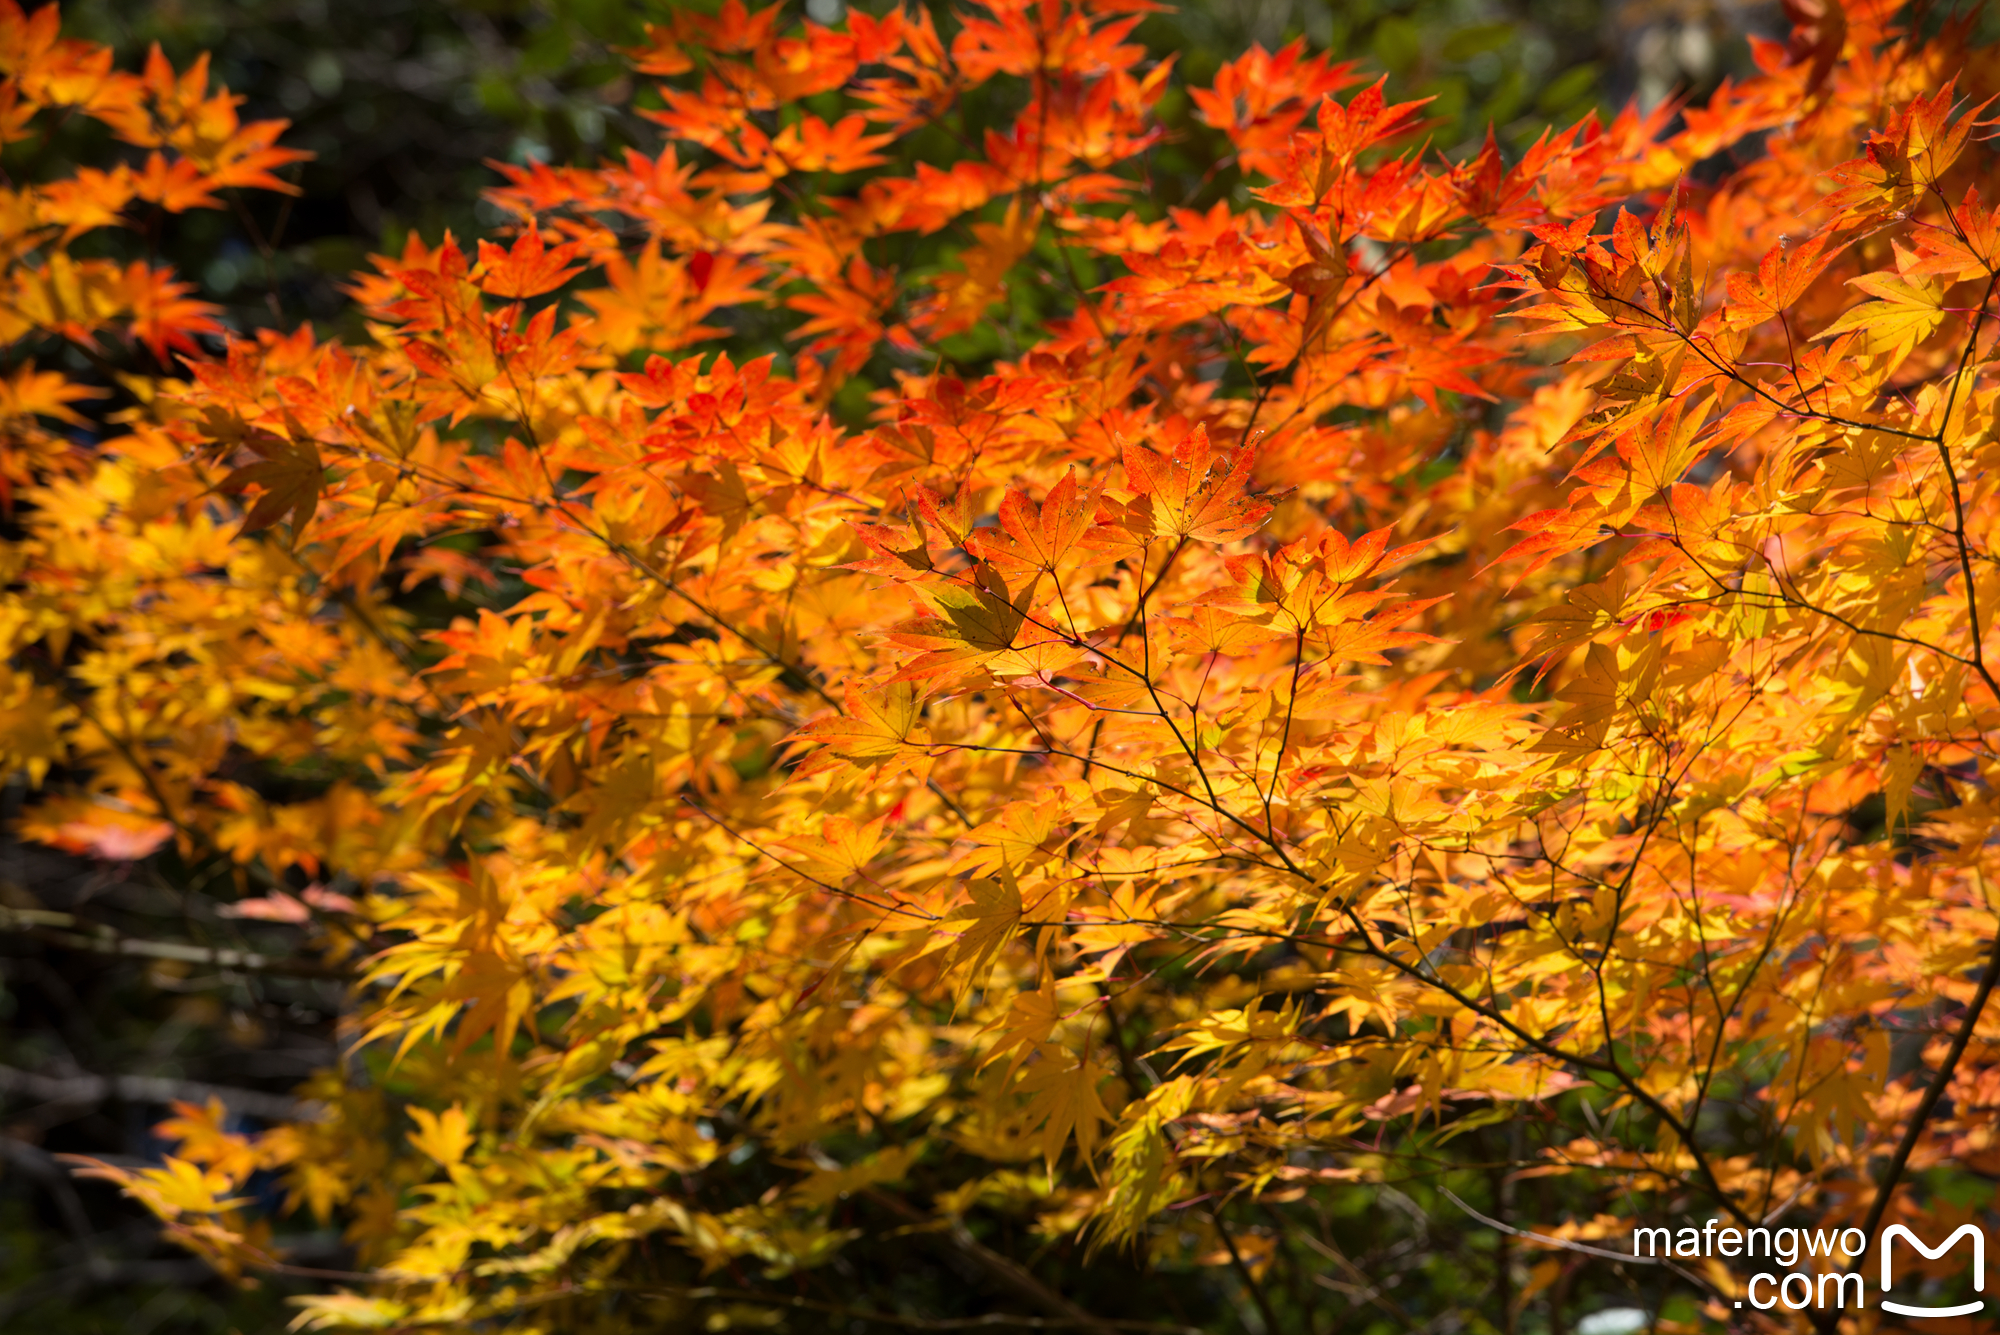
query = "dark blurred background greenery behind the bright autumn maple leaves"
(0, 0, 1782, 1335)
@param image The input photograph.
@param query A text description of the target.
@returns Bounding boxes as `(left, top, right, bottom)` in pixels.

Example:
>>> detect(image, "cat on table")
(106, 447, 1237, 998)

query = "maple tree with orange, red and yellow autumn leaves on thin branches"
(0, 0, 2000, 1333)
